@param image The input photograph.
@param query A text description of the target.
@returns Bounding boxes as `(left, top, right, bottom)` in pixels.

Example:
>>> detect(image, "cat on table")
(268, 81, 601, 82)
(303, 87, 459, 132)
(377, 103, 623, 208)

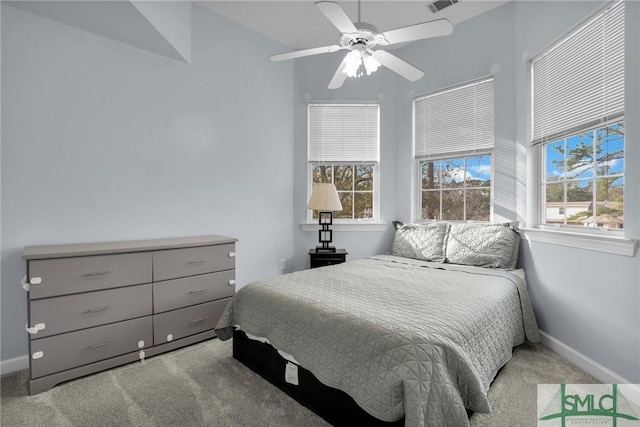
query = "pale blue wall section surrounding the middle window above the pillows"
(397, 0, 524, 227)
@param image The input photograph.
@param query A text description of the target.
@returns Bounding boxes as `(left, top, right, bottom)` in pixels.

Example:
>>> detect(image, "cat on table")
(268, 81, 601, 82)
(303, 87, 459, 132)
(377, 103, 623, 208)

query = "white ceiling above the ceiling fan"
(198, 0, 509, 53)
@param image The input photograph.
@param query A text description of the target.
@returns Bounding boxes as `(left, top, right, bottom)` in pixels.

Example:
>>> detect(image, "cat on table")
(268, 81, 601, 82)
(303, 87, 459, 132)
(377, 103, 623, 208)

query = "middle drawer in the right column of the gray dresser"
(153, 270, 236, 313)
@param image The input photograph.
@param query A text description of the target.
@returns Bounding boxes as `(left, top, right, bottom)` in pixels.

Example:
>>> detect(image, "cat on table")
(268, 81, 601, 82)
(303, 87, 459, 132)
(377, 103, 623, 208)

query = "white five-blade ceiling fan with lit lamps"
(271, 0, 453, 89)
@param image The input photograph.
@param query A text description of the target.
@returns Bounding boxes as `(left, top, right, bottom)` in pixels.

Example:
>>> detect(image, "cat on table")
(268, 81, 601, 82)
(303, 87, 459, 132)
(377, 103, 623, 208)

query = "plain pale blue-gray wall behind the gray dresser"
(1, 5, 294, 361)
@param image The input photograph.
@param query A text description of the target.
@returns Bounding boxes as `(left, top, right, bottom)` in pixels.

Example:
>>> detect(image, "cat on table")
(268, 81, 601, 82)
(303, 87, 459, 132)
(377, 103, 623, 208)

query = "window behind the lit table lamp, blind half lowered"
(308, 104, 380, 222)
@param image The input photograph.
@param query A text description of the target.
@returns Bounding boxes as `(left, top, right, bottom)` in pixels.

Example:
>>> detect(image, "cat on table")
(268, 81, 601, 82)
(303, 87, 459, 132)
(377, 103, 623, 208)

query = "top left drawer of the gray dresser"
(27, 252, 152, 299)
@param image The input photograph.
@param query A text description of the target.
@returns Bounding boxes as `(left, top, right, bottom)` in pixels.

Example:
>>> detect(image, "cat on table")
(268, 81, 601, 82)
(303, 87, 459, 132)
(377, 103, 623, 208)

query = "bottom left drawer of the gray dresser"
(31, 317, 153, 378)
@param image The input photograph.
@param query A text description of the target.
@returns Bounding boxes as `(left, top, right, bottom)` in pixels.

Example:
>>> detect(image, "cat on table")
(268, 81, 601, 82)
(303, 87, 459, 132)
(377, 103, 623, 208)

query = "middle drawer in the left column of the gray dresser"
(29, 284, 153, 339)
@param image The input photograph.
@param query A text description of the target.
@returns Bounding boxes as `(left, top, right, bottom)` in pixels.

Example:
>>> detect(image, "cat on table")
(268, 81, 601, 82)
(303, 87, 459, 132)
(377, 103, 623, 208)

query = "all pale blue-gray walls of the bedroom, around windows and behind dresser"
(1, 1, 640, 383)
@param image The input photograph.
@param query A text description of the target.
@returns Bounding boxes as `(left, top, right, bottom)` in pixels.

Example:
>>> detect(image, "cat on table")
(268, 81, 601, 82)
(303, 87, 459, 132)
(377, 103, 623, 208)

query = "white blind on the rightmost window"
(531, 1, 624, 144)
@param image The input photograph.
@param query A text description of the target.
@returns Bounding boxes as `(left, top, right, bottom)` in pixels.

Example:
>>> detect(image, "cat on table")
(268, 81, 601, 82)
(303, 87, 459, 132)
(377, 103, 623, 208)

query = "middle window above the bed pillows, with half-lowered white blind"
(414, 78, 494, 221)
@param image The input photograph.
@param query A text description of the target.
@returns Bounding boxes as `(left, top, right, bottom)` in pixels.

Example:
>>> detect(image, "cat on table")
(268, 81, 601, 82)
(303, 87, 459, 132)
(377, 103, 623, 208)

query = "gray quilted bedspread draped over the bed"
(216, 225, 539, 426)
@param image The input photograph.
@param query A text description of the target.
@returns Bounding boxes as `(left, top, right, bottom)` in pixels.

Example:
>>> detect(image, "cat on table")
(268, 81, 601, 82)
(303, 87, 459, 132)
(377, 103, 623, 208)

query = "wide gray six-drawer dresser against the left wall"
(22, 235, 237, 395)
